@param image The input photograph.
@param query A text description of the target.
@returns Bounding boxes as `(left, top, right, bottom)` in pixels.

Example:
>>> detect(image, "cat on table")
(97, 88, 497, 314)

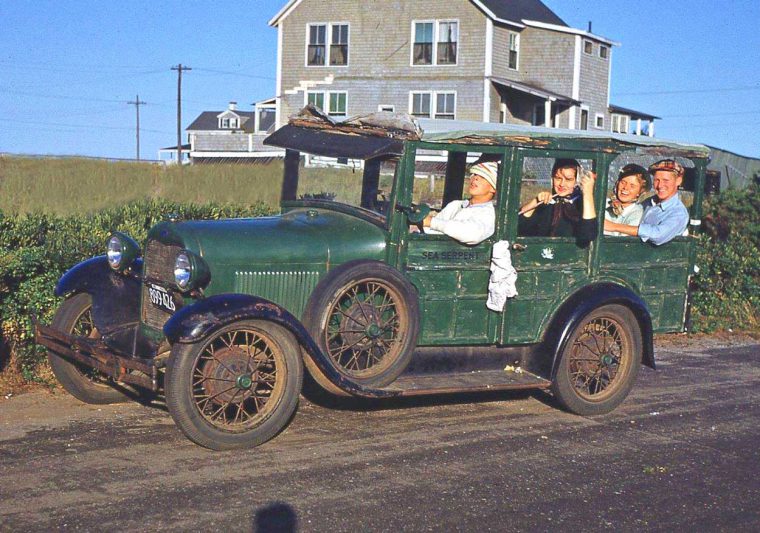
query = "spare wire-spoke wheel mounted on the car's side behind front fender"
(304, 261, 420, 388)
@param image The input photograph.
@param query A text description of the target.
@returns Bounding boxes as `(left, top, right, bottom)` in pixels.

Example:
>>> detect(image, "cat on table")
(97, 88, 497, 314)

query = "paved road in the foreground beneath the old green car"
(0, 340, 760, 531)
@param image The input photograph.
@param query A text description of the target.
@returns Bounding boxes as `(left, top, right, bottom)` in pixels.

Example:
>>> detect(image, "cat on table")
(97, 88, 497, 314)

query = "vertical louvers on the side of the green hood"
(235, 271, 319, 316)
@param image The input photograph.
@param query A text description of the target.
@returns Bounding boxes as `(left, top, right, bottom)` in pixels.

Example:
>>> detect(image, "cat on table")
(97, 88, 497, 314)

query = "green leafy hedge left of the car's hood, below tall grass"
(0, 200, 271, 380)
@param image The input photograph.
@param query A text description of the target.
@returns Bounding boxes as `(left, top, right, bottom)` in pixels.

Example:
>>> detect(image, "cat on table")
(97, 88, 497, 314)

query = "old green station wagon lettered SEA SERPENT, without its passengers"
(38, 110, 707, 449)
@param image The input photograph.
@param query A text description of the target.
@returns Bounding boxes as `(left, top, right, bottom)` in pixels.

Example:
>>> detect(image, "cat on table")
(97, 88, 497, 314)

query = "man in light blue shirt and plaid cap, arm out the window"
(604, 159, 689, 246)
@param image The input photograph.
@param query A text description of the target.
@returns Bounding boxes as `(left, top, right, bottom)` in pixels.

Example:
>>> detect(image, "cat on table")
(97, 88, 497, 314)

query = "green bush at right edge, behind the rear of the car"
(692, 184, 760, 332)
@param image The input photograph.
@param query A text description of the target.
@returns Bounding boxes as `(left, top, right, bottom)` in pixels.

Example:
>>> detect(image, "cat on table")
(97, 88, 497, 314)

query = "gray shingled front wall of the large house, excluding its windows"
(281, 0, 486, 120)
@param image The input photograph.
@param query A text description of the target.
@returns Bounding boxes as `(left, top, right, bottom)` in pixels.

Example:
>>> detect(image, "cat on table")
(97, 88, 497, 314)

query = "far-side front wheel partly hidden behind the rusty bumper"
(48, 293, 128, 404)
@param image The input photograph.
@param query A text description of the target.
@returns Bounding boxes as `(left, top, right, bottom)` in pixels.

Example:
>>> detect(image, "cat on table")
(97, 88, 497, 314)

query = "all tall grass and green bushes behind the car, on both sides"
(0, 158, 760, 393)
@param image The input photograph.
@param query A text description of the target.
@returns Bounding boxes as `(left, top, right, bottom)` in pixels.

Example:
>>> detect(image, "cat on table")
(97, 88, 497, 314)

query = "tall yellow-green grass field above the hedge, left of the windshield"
(0, 156, 282, 215)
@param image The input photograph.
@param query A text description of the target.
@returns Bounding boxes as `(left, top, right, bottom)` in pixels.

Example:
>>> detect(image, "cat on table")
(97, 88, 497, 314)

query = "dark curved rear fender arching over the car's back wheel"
(544, 282, 655, 379)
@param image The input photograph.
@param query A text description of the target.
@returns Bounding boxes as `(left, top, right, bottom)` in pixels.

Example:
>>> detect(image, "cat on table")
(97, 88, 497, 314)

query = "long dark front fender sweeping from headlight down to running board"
(164, 294, 398, 398)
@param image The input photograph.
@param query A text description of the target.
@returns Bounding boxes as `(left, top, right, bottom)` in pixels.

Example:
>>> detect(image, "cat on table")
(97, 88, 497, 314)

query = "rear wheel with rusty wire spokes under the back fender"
(553, 305, 642, 414)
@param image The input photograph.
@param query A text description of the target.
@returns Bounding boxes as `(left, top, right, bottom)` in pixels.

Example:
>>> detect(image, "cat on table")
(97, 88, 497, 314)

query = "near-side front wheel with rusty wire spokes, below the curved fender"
(166, 321, 303, 450)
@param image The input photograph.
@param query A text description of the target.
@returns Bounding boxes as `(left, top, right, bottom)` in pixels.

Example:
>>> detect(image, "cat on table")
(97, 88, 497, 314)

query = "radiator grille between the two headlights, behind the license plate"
(141, 237, 183, 329)
